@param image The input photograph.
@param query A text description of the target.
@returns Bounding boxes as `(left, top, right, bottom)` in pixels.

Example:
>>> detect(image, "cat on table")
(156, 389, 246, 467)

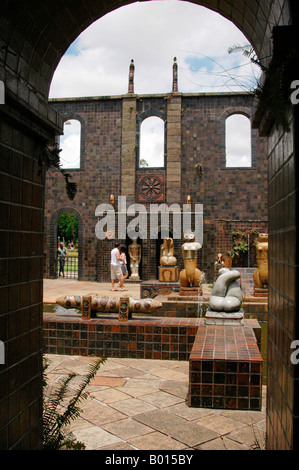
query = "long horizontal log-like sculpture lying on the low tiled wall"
(56, 294, 162, 321)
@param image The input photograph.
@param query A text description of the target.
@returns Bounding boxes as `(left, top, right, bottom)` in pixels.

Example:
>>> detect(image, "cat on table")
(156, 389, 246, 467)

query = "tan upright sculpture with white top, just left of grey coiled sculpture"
(180, 232, 202, 287)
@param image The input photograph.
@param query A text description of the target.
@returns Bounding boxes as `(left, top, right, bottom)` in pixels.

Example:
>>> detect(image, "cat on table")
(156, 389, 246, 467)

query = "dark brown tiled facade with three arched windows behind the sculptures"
(45, 93, 267, 281)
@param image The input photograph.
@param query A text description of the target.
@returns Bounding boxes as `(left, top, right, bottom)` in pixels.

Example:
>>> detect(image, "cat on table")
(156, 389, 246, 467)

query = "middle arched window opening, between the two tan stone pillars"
(139, 116, 165, 168)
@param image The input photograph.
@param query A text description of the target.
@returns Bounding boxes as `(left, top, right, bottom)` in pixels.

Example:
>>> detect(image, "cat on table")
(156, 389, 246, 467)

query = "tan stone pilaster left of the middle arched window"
(121, 96, 136, 204)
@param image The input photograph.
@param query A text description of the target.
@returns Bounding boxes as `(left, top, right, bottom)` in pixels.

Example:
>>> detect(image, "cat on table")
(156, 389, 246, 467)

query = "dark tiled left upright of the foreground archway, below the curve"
(0, 108, 55, 450)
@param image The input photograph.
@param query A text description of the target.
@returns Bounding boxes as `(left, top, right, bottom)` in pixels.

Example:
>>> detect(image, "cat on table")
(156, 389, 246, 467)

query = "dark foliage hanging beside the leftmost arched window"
(39, 144, 77, 201)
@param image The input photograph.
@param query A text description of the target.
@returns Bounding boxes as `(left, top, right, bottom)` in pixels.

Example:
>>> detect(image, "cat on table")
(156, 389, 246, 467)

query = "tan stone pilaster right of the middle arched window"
(166, 93, 182, 204)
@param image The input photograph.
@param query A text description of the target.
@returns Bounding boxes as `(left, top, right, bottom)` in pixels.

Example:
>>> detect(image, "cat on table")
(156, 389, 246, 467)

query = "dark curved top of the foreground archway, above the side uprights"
(0, 0, 289, 98)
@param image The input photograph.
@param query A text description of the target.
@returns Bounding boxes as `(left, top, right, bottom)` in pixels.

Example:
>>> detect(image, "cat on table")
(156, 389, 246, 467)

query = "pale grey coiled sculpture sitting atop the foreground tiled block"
(209, 268, 243, 312)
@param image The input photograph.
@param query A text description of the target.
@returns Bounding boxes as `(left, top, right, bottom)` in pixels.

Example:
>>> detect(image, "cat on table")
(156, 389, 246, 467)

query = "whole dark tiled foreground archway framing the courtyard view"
(0, 0, 298, 450)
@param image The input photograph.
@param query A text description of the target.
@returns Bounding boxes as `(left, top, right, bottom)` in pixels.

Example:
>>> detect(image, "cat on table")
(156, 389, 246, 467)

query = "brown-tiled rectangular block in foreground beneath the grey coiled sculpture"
(188, 319, 263, 411)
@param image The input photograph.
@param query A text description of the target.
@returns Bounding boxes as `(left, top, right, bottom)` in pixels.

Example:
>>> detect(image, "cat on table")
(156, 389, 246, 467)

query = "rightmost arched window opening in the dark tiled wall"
(225, 114, 252, 168)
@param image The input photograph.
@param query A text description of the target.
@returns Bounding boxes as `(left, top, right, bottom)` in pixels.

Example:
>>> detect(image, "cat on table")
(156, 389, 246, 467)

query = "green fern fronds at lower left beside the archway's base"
(43, 358, 106, 450)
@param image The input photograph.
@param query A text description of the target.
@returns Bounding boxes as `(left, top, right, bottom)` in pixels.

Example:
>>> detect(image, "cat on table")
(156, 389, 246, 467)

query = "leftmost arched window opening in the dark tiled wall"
(59, 119, 81, 169)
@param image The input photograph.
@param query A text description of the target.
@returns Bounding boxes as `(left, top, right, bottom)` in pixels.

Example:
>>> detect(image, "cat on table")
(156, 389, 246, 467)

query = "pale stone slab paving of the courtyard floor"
(44, 279, 266, 451)
